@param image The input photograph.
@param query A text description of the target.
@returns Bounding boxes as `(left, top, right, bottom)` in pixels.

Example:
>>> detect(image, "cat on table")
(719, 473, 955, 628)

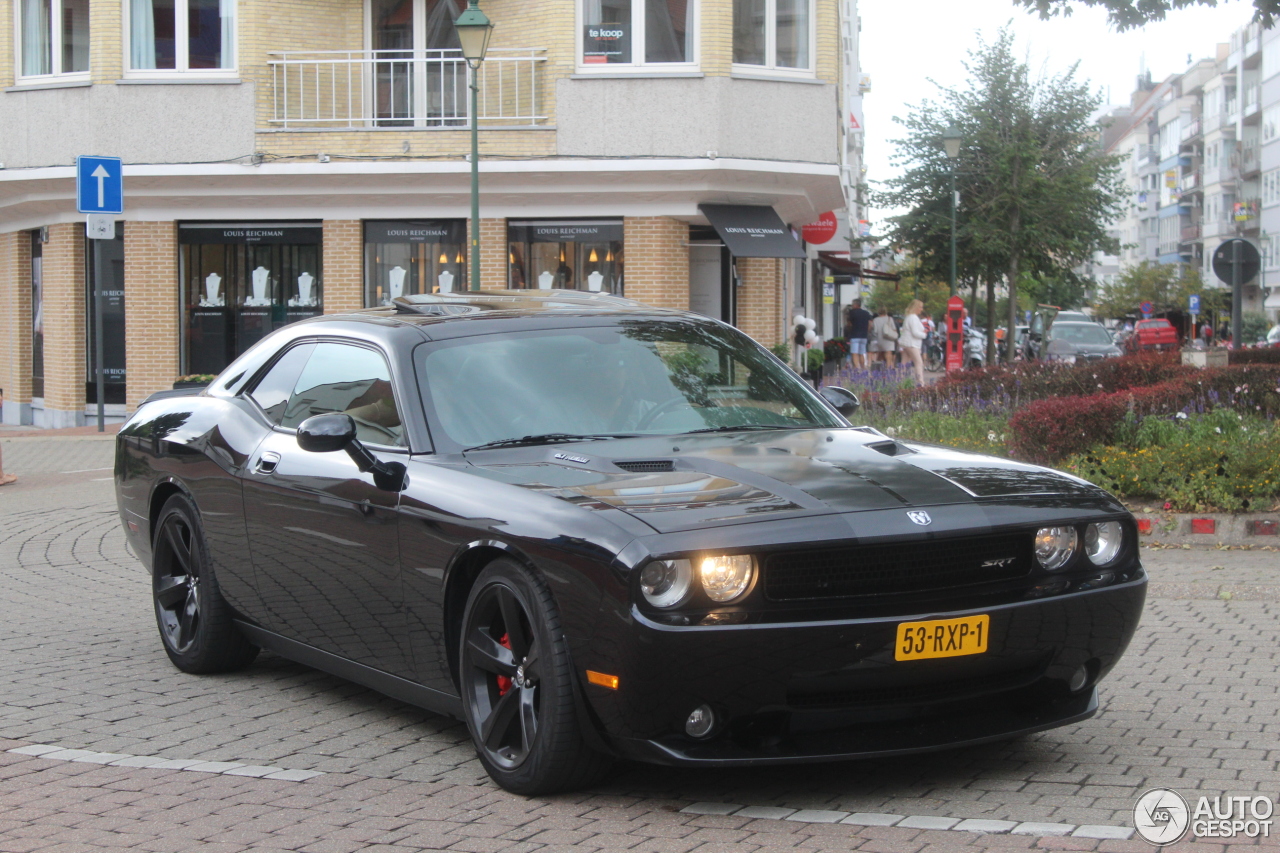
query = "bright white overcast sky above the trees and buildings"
(858, 0, 1253, 220)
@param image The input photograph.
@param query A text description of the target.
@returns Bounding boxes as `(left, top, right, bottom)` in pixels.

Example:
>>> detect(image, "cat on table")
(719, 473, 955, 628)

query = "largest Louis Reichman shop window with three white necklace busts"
(178, 223, 324, 374)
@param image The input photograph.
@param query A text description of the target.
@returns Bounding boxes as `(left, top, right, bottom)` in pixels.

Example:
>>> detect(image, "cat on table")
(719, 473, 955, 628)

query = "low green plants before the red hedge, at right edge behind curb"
(1064, 409, 1280, 512)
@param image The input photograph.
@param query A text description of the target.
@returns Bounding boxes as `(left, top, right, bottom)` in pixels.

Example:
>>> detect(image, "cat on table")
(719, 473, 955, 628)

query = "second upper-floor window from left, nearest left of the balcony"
(125, 0, 236, 72)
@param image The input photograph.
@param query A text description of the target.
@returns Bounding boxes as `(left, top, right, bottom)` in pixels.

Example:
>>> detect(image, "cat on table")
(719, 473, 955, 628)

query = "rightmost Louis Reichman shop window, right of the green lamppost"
(507, 219, 622, 296)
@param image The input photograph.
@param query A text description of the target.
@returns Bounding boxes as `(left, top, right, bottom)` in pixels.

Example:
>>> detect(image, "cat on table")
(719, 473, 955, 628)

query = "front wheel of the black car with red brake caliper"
(460, 560, 609, 794)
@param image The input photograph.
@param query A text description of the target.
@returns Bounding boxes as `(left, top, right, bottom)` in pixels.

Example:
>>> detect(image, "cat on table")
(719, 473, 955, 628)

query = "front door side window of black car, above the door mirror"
(280, 343, 404, 446)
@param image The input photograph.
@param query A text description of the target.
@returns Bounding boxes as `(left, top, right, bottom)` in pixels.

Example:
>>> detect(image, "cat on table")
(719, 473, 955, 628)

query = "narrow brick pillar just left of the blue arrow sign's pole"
(42, 222, 86, 427)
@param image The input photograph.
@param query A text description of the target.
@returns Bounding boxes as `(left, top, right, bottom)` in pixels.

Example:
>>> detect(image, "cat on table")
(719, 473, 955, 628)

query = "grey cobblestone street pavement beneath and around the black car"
(0, 437, 1280, 853)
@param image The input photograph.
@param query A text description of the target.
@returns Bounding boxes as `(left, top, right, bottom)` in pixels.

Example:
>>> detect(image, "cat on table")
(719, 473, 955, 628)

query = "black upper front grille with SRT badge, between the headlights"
(764, 533, 1032, 601)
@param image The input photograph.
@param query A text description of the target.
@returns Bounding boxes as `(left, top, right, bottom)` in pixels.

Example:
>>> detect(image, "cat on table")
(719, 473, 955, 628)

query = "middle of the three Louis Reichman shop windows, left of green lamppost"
(365, 219, 467, 307)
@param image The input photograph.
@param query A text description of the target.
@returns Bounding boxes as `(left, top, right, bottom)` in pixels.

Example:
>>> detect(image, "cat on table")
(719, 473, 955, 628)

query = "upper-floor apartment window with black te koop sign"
(579, 0, 698, 70)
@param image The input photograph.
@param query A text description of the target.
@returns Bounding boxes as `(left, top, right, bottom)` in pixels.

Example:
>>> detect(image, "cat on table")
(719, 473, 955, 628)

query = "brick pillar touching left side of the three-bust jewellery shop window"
(124, 222, 180, 411)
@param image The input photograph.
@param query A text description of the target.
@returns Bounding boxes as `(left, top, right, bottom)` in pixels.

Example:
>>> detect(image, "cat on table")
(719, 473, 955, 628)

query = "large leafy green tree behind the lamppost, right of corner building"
(877, 27, 1124, 360)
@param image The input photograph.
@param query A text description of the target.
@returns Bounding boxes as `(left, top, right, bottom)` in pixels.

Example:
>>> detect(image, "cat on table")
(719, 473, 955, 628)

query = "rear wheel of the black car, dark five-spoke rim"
(151, 494, 259, 674)
